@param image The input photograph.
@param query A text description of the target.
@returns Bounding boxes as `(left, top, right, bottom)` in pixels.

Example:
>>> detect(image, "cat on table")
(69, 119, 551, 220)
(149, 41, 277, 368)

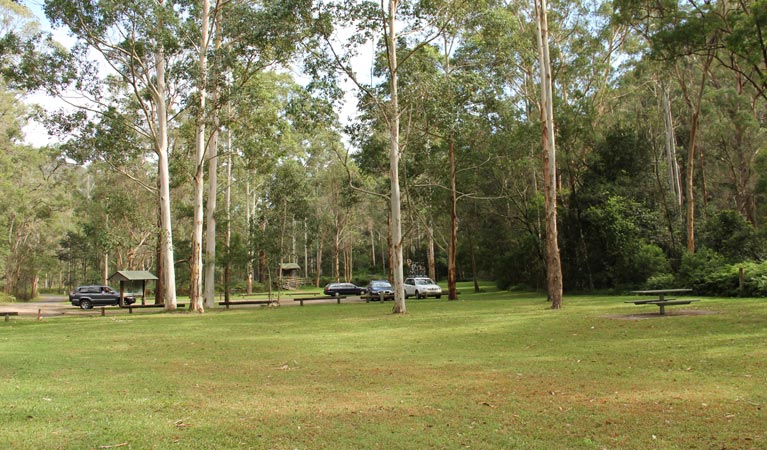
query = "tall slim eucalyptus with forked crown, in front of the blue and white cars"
(315, 0, 465, 314)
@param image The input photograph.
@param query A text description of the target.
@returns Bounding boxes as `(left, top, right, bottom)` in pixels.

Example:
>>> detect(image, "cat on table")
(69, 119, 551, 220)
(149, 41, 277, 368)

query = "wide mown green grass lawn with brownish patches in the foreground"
(0, 286, 767, 449)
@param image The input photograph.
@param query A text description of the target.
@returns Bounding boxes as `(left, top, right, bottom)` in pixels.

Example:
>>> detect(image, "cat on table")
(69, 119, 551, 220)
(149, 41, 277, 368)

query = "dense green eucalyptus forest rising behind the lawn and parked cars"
(0, 0, 767, 312)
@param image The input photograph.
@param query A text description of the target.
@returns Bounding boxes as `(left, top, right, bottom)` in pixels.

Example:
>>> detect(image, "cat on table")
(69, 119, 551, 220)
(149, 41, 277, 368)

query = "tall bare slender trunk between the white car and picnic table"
(535, 0, 562, 309)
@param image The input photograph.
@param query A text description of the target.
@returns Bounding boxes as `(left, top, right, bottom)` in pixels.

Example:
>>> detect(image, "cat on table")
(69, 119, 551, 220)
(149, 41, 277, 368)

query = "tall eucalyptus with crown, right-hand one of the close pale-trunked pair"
(195, 0, 311, 307)
